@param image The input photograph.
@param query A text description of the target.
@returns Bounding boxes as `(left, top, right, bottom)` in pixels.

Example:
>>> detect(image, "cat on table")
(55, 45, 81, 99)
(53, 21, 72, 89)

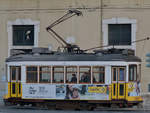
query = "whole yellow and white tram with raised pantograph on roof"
(4, 10, 142, 108)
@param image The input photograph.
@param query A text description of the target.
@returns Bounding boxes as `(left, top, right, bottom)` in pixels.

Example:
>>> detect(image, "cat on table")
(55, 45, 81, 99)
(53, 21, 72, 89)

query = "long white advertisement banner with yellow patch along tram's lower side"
(23, 84, 110, 100)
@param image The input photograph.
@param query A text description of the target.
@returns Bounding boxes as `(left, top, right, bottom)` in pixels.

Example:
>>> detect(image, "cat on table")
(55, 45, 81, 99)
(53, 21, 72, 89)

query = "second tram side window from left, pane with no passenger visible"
(39, 66, 51, 83)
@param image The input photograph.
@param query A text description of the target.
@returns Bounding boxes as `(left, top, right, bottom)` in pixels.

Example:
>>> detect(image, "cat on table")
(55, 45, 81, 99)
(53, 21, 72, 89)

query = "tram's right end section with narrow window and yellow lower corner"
(126, 63, 143, 103)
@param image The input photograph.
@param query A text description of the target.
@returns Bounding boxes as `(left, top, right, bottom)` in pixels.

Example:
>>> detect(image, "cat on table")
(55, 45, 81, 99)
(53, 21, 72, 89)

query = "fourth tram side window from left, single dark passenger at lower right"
(66, 66, 77, 83)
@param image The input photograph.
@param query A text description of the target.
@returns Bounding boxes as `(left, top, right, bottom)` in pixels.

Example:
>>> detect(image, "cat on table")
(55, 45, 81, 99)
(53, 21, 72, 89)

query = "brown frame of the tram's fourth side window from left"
(65, 66, 78, 84)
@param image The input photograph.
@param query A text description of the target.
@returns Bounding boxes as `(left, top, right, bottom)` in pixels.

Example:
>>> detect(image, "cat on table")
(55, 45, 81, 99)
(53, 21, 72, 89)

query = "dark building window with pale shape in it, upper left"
(13, 25, 34, 46)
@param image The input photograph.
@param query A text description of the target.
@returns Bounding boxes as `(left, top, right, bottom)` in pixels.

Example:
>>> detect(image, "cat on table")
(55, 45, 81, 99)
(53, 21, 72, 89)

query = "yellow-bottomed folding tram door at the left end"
(10, 66, 21, 97)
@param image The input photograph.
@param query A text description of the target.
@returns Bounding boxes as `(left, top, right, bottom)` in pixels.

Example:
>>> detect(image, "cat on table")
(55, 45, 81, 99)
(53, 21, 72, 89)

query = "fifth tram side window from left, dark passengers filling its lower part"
(79, 67, 91, 83)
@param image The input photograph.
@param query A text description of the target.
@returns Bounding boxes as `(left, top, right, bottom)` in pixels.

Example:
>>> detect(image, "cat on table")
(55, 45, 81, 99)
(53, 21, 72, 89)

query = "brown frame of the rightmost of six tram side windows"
(91, 66, 105, 84)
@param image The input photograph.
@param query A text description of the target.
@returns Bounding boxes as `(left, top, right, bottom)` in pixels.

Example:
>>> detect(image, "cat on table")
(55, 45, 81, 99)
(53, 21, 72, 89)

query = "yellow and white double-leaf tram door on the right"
(112, 67, 126, 99)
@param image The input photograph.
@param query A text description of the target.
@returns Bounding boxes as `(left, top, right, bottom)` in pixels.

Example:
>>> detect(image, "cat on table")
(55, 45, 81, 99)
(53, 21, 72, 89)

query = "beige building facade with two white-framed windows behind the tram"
(0, 0, 150, 99)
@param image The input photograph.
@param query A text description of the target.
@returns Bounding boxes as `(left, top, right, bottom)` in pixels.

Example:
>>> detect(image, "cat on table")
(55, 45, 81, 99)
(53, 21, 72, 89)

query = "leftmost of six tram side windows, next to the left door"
(26, 66, 38, 83)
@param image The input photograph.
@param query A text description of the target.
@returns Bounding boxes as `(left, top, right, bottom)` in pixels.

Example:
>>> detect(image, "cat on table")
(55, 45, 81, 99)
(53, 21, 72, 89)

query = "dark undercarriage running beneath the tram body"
(4, 98, 142, 110)
